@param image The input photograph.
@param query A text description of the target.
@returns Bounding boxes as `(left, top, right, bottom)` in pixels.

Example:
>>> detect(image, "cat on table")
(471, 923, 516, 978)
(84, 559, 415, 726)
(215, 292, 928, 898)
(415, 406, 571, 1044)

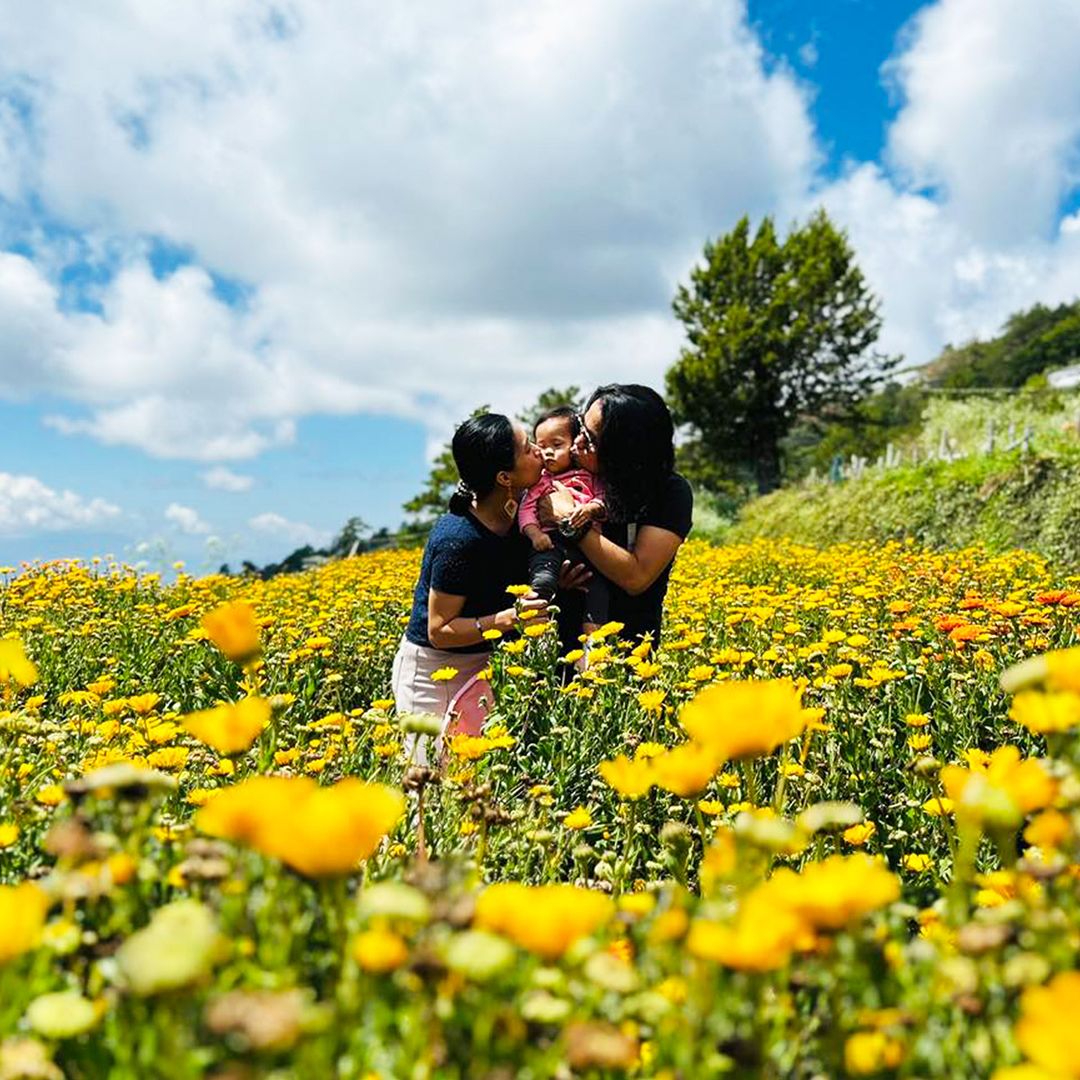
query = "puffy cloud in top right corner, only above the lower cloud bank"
(887, 0, 1080, 244)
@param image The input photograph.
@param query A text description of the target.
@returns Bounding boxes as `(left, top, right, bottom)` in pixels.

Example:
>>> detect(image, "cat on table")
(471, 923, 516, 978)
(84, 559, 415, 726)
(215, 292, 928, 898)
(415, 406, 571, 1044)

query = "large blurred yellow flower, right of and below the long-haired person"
(679, 679, 808, 760)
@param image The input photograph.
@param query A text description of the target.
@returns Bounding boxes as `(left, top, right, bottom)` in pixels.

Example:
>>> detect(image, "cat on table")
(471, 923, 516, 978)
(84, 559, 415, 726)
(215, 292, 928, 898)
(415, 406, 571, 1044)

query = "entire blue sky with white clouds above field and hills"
(0, 0, 1080, 570)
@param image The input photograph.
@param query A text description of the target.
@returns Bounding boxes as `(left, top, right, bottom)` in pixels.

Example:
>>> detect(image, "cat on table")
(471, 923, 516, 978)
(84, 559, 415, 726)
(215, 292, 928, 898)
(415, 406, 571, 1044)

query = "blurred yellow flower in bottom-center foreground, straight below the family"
(473, 882, 615, 960)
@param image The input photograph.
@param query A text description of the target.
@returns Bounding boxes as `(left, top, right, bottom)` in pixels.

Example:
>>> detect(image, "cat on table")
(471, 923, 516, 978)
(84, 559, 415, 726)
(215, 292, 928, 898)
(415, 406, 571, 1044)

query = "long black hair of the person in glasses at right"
(585, 382, 675, 522)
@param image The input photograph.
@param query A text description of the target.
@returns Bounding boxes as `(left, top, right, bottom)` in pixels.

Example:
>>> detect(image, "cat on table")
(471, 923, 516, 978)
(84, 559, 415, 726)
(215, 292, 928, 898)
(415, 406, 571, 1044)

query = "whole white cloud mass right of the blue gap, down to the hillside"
(797, 0, 1080, 363)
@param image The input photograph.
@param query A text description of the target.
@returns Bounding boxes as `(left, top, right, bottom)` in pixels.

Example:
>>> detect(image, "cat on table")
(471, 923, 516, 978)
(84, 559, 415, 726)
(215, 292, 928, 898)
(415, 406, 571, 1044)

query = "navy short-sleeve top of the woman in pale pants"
(405, 514, 531, 652)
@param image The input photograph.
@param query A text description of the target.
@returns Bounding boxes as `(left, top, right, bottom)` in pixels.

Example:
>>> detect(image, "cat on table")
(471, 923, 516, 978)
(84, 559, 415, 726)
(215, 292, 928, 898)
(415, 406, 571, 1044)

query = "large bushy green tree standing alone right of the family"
(666, 211, 896, 492)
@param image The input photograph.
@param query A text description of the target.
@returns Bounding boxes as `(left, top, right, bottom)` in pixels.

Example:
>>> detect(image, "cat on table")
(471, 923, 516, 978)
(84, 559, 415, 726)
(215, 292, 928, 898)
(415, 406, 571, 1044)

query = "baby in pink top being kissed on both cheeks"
(517, 405, 608, 634)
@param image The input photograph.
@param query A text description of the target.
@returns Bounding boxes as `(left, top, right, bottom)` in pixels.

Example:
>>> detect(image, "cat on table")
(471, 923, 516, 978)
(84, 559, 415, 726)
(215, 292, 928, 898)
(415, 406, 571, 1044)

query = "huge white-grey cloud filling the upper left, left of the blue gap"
(0, 0, 818, 461)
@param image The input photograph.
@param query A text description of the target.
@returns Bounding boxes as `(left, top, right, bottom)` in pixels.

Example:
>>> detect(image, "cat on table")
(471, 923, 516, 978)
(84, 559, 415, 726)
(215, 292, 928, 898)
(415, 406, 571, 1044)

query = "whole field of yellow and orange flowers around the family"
(0, 542, 1080, 1080)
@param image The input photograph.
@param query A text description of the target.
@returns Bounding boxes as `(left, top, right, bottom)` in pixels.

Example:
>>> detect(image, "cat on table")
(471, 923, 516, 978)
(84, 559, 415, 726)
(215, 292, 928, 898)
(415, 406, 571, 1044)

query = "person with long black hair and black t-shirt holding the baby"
(551, 383, 693, 643)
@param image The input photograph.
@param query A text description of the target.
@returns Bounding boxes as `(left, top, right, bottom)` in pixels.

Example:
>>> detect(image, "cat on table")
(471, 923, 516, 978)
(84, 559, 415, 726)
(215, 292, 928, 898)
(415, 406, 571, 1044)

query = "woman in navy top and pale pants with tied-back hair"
(393, 413, 546, 751)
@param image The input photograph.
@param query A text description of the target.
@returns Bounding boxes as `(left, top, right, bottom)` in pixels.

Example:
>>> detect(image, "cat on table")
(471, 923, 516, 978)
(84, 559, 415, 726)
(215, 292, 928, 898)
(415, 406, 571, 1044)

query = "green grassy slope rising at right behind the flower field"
(717, 451, 1080, 569)
